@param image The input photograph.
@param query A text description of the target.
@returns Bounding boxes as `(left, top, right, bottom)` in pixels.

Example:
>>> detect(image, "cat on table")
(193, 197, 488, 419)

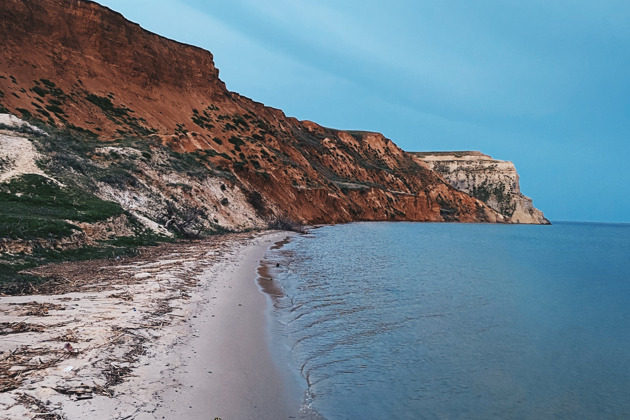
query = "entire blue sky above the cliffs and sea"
(99, 0, 630, 222)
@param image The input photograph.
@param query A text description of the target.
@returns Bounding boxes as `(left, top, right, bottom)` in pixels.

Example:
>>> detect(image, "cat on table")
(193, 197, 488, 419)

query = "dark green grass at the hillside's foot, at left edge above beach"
(0, 174, 145, 293)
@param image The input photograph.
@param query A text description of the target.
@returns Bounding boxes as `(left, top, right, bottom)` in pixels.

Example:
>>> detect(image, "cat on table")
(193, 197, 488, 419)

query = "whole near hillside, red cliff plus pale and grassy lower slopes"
(0, 0, 548, 292)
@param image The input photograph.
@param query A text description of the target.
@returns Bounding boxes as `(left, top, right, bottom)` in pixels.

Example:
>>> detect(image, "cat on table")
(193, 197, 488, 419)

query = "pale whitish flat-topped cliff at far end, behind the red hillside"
(412, 152, 549, 224)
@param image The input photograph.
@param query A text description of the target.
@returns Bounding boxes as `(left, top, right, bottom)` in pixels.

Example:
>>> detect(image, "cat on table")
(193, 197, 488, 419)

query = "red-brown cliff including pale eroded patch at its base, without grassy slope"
(0, 0, 505, 240)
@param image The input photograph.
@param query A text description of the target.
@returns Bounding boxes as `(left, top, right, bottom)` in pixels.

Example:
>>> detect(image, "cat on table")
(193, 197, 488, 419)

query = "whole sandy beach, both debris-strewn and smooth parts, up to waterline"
(0, 232, 299, 420)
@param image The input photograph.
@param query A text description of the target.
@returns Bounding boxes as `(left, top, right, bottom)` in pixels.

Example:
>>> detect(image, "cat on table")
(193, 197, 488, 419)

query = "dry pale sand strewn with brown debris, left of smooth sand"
(0, 233, 256, 419)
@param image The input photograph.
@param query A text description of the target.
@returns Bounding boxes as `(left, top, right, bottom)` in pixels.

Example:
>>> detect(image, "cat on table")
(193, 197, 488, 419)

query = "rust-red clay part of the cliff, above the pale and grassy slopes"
(0, 0, 504, 224)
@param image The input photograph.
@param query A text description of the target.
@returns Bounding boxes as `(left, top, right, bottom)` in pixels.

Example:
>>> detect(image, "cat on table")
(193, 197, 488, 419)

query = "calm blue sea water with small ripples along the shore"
(269, 223, 630, 420)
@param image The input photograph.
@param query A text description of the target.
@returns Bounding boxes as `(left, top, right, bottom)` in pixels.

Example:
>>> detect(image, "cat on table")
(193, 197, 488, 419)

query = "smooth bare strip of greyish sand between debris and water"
(156, 234, 299, 420)
